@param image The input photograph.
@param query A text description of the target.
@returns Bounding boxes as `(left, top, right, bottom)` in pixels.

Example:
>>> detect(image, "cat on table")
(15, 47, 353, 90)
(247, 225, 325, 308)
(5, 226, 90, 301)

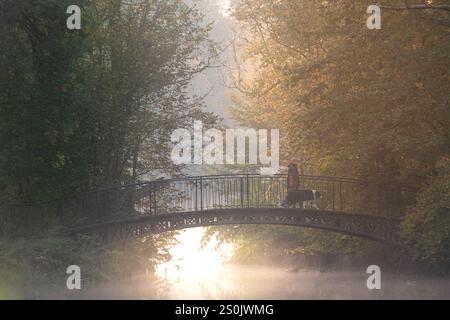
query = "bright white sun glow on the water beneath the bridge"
(156, 228, 233, 299)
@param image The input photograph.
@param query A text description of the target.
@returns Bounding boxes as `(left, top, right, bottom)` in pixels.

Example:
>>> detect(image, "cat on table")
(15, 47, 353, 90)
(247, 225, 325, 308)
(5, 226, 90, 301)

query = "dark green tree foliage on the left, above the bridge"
(0, 0, 215, 201)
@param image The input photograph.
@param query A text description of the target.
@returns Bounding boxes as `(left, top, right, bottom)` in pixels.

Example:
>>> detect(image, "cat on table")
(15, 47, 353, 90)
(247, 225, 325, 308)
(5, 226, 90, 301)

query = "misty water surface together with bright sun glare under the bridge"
(17, 229, 450, 300)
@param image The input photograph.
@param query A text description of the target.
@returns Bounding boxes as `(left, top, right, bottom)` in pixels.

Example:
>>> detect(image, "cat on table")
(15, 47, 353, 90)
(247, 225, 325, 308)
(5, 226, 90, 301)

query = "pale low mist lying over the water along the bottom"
(27, 266, 450, 300)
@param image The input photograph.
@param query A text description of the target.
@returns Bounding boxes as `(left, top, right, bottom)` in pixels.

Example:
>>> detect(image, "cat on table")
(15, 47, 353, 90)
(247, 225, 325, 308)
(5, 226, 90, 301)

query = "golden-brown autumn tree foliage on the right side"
(209, 0, 450, 270)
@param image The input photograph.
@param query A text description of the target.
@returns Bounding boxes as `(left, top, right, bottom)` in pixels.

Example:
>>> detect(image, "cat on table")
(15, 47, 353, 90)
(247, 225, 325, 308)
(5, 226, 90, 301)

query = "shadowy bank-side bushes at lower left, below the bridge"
(0, 236, 174, 299)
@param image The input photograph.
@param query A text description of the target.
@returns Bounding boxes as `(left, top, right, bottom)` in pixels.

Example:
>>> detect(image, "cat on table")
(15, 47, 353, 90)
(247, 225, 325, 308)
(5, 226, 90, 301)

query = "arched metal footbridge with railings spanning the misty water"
(0, 174, 407, 244)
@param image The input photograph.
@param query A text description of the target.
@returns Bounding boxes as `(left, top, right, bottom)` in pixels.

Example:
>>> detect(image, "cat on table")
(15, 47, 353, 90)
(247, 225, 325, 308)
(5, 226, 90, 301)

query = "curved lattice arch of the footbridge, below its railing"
(70, 208, 400, 245)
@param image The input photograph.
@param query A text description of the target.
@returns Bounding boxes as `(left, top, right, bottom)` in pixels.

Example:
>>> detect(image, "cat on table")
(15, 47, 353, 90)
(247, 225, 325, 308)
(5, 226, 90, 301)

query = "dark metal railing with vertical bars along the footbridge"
(0, 174, 412, 235)
